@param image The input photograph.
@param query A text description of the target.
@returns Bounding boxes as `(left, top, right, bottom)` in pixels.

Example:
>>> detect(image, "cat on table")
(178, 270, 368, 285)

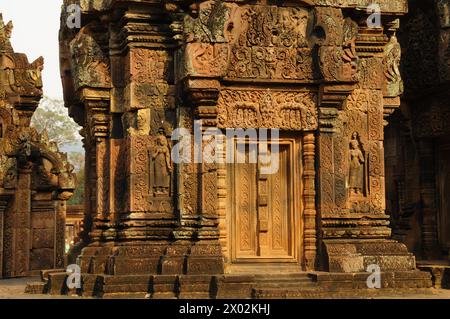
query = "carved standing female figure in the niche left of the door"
(152, 134, 173, 195)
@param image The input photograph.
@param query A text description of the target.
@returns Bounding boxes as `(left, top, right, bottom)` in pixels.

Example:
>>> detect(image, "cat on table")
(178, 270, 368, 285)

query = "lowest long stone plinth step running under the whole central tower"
(27, 270, 432, 299)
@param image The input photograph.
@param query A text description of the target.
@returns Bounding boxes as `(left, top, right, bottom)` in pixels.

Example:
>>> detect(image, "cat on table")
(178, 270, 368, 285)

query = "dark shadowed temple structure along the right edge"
(385, 0, 450, 279)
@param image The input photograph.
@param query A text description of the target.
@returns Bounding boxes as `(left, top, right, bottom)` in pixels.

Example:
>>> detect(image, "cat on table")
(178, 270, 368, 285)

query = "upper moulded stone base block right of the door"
(324, 239, 416, 273)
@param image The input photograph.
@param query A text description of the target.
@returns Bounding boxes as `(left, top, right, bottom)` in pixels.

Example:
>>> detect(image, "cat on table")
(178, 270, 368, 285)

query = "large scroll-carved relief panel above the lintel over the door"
(227, 6, 318, 81)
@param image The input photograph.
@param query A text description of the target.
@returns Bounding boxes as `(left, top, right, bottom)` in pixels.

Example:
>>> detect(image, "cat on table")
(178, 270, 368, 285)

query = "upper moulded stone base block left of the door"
(78, 241, 224, 276)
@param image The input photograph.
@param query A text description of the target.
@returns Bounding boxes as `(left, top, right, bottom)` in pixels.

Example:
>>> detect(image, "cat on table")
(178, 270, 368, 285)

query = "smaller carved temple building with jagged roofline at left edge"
(0, 14, 75, 278)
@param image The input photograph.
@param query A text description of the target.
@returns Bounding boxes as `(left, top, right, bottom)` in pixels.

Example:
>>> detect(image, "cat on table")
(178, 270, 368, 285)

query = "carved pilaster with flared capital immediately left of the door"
(185, 78, 224, 274)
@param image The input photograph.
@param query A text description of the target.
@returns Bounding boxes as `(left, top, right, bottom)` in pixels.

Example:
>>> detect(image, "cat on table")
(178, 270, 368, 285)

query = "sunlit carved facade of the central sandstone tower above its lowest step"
(56, 0, 432, 297)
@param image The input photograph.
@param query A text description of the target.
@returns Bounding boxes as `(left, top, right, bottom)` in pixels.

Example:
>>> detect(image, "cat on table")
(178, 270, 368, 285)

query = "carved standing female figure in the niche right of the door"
(349, 132, 365, 195)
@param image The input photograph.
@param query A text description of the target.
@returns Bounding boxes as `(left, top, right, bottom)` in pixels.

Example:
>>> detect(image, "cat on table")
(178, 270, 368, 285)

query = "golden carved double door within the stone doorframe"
(231, 140, 301, 262)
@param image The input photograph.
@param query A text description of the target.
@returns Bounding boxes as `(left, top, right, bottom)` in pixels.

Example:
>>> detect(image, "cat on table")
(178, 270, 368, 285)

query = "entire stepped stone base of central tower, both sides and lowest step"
(28, 240, 432, 299)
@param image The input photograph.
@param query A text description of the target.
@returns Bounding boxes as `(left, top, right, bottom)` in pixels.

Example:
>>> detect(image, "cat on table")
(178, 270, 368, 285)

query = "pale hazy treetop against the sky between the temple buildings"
(31, 97, 81, 147)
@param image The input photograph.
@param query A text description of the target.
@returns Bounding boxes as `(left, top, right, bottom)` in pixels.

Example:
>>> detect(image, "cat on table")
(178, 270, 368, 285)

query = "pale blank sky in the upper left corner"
(0, 0, 63, 99)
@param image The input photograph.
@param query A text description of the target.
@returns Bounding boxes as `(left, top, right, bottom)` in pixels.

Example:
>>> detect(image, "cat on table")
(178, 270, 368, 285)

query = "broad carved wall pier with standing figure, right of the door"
(318, 8, 425, 285)
